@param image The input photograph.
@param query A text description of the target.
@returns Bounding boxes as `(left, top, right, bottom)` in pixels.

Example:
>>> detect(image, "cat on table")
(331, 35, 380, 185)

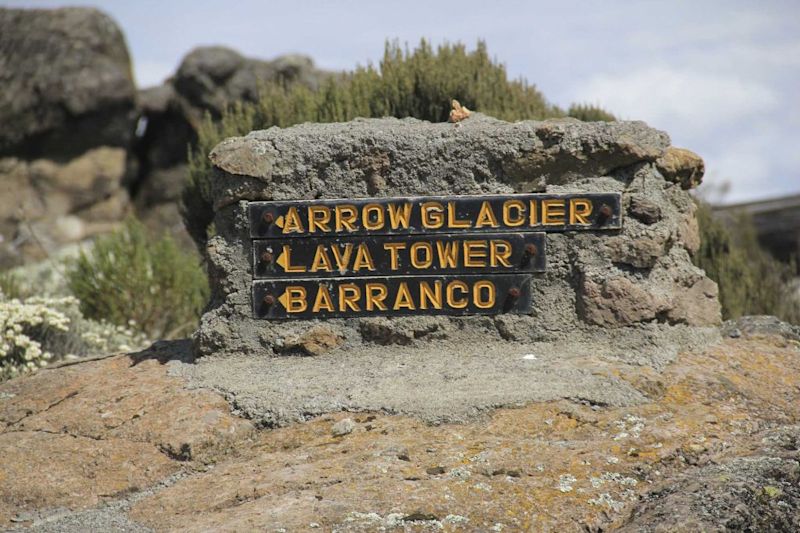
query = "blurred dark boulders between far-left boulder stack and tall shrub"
(133, 46, 330, 246)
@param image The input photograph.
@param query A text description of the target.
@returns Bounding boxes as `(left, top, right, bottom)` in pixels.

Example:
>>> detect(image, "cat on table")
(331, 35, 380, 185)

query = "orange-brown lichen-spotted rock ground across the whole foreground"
(0, 320, 800, 531)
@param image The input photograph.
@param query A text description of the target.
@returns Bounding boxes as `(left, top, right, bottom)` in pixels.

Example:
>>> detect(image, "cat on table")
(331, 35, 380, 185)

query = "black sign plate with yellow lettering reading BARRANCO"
(253, 274, 531, 319)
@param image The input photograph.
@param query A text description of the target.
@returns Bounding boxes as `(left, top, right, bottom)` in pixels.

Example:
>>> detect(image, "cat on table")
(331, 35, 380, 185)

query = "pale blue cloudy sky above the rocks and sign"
(7, 0, 800, 203)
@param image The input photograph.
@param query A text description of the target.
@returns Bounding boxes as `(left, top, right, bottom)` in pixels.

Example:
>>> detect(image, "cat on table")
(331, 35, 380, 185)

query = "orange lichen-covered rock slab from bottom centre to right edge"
(132, 340, 800, 531)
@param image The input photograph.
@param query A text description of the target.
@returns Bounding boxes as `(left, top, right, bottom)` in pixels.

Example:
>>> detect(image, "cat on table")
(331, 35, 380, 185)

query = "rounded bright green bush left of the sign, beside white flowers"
(67, 219, 208, 338)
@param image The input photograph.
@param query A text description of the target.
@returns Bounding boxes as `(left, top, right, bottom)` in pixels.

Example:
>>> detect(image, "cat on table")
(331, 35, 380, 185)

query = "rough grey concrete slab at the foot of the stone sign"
(173, 322, 719, 427)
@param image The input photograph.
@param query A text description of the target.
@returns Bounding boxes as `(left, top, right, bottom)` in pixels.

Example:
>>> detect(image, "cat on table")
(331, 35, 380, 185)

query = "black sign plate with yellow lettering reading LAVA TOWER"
(253, 232, 546, 278)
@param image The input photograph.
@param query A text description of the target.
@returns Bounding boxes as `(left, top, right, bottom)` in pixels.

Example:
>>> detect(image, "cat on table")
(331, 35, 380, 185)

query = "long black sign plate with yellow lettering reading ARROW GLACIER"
(249, 193, 622, 238)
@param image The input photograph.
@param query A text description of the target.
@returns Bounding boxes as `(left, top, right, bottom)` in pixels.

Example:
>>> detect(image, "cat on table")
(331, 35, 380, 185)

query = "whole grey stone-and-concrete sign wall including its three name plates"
(195, 115, 719, 355)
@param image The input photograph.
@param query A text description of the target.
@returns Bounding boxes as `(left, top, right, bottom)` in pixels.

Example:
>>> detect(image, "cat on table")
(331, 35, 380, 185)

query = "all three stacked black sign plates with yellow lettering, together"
(248, 193, 621, 319)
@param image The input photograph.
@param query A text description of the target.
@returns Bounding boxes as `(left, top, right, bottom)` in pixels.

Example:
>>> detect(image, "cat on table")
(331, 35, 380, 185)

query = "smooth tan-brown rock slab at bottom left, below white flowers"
(0, 355, 252, 526)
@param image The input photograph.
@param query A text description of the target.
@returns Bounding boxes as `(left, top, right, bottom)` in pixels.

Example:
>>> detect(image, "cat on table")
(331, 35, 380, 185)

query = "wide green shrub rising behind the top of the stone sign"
(183, 40, 613, 250)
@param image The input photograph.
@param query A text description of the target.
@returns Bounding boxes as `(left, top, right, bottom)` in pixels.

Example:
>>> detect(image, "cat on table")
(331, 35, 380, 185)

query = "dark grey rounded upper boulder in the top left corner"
(0, 8, 136, 158)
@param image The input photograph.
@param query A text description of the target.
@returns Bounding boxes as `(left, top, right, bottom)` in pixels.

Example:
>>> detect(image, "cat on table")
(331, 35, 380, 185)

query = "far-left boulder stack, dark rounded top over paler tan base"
(0, 8, 136, 267)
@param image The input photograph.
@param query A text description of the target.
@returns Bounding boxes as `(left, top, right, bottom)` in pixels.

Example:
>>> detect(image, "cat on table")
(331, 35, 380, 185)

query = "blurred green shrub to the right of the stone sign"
(695, 202, 800, 324)
